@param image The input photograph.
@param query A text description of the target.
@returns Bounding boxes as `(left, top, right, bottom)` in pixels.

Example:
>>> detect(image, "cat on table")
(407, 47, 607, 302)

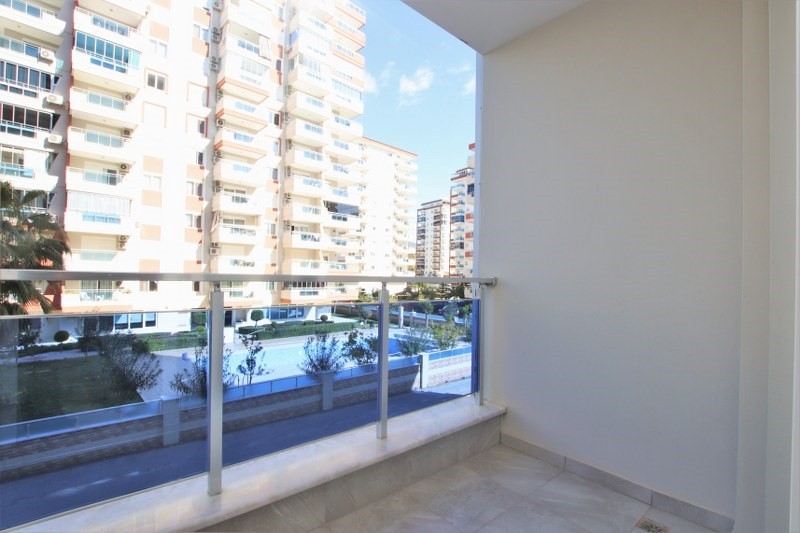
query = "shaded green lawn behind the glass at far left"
(17, 356, 142, 422)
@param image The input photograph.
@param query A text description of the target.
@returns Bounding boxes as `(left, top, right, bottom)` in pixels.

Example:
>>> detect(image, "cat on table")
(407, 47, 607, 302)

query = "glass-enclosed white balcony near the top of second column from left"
(72, 48, 142, 95)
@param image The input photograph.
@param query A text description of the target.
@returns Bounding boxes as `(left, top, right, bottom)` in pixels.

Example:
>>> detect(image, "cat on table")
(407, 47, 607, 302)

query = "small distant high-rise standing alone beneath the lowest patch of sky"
(416, 199, 450, 277)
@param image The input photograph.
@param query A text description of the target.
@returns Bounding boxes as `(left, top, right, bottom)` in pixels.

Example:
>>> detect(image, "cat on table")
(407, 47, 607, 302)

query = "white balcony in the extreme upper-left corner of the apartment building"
(0, 0, 66, 48)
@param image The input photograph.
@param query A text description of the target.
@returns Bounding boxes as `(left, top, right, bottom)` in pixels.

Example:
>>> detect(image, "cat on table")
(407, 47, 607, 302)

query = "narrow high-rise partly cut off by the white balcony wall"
(450, 143, 475, 277)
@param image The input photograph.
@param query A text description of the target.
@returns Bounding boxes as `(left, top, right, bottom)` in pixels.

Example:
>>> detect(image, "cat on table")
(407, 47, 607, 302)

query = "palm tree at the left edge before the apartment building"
(0, 182, 70, 315)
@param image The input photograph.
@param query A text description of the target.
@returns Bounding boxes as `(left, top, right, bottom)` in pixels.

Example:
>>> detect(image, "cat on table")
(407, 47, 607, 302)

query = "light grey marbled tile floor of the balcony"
(315, 445, 710, 533)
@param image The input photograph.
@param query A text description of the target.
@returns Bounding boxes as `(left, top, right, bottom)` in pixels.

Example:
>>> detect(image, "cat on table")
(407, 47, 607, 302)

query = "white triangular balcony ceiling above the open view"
(403, 0, 587, 54)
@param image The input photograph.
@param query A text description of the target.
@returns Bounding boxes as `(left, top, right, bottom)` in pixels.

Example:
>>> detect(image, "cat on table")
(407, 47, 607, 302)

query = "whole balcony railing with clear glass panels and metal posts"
(0, 270, 496, 528)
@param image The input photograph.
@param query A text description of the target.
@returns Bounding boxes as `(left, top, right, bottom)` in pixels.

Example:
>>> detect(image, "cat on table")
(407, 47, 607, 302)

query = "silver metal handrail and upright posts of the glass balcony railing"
(0, 269, 496, 502)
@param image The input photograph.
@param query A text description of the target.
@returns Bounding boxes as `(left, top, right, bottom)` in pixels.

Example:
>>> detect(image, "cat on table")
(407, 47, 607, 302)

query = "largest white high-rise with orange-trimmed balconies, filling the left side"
(0, 0, 416, 327)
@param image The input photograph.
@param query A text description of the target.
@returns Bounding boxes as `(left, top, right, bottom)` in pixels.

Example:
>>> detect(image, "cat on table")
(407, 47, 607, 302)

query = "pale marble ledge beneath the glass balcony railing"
(15, 396, 505, 532)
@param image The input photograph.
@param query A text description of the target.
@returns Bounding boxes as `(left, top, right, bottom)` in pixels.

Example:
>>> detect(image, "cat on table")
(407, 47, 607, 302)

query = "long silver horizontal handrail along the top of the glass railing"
(0, 269, 497, 287)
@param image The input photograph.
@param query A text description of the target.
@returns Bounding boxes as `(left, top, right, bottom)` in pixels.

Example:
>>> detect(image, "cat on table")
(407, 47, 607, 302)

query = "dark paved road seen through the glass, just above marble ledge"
(0, 385, 466, 529)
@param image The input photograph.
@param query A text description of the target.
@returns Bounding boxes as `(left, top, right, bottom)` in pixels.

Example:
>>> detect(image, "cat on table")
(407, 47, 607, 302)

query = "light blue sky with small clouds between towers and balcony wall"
(357, 0, 476, 203)
